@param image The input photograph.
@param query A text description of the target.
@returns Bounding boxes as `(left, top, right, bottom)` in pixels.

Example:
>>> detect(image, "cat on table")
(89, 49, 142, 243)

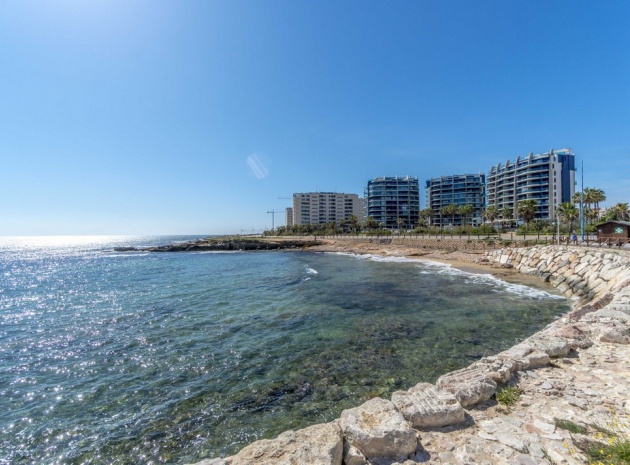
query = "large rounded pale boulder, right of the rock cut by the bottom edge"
(339, 398, 418, 460)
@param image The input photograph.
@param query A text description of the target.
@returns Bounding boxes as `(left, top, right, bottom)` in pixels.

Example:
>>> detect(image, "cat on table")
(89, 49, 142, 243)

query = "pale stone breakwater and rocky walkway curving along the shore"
(190, 247, 630, 465)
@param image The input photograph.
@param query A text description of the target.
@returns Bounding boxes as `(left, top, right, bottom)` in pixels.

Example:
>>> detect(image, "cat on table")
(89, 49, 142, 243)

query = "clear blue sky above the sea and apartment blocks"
(0, 0, 630, 235)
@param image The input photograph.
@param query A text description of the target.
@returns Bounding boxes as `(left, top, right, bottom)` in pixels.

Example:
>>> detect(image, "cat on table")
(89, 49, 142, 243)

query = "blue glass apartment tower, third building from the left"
(426, 174, 486, 227)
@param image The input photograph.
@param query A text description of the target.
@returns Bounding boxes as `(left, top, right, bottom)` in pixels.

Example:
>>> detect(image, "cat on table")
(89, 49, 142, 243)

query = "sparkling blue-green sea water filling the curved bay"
(0, 236, 570, 465)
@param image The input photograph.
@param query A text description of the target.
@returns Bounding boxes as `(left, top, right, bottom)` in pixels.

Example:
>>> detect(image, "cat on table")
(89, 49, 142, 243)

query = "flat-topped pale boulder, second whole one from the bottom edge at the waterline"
(392, 383, 465, 428)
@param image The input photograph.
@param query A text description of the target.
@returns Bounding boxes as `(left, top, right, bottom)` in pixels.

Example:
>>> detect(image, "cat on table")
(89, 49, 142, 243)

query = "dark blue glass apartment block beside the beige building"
(365, 176, 420, 229)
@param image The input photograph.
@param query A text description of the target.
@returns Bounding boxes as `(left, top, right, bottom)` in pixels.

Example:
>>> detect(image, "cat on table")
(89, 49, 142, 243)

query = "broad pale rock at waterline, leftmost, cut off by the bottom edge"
(229, 422, 343, 465)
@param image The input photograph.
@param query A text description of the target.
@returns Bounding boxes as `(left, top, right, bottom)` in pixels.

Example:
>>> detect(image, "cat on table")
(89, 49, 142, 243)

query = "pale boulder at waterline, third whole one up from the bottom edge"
(436, 365, 497, 407)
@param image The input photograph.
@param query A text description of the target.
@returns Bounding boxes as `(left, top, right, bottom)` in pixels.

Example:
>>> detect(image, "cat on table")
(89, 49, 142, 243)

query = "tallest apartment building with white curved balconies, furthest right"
(486, 148, 576, 220)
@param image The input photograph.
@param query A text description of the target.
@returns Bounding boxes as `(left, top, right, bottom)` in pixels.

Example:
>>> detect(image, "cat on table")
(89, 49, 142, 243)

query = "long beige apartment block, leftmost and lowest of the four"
(293, 192, 362, 225)
